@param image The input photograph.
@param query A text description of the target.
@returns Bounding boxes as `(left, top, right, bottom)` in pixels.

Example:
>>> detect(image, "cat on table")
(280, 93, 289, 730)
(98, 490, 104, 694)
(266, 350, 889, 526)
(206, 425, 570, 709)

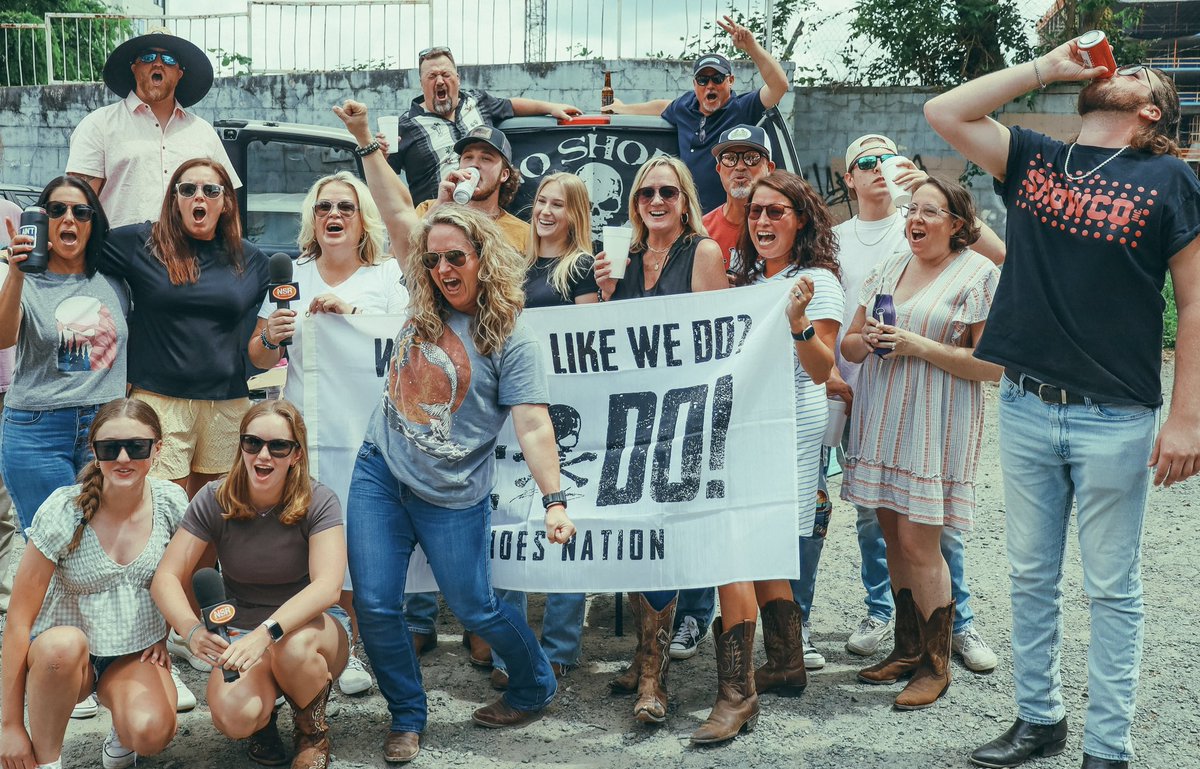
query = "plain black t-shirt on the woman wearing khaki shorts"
(100, 222, 268, 401)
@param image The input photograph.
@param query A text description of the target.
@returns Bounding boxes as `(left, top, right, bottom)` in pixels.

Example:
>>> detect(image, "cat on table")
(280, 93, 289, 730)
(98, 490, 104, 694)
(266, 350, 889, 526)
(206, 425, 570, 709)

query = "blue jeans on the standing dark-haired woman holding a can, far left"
(0, 405, 100, 531)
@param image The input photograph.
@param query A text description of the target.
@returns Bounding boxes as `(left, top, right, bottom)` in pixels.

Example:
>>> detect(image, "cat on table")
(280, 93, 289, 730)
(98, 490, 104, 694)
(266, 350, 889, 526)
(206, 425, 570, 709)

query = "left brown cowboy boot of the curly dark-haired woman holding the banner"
(691, 619, 753, 745)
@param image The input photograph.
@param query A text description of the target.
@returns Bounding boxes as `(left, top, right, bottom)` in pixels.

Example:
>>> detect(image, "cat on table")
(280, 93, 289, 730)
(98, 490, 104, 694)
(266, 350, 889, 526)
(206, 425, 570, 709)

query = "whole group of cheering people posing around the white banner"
(0, 18, 1200, 769)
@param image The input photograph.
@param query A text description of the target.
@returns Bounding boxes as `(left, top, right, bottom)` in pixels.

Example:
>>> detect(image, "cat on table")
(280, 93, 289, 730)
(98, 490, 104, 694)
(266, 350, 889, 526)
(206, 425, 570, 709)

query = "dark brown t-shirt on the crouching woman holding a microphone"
(180, 481, 342, 629)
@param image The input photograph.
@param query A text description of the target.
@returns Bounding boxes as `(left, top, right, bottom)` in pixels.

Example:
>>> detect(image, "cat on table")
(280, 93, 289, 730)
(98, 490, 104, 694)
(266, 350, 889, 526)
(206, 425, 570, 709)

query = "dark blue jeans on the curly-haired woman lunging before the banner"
(346, 443, 557, 733)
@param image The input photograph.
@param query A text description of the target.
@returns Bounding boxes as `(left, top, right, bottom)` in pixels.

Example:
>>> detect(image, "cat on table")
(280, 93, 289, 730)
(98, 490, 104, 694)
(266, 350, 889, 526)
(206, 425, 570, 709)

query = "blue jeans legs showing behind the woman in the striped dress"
(854, 505, 974, 633)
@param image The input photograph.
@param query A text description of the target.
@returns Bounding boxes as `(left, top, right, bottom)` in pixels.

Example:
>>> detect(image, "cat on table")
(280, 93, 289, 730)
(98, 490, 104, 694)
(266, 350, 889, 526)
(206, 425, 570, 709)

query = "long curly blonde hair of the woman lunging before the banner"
(404, 204, 526, 355)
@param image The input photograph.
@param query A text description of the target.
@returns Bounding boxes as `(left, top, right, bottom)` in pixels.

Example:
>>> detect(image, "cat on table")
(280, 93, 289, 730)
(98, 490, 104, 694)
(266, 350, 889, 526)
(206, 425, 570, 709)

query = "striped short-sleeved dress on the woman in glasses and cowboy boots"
(841, 250, 1000, 530)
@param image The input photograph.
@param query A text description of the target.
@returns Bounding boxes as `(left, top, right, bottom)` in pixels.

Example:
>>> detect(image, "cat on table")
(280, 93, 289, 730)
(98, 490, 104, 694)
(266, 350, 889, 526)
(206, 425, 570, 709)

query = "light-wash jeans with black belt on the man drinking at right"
(1000, 377, 1158, 761)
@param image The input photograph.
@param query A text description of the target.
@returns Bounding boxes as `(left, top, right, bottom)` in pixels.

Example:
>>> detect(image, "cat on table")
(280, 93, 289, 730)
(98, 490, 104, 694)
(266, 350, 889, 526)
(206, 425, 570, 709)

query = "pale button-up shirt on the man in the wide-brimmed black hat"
(67, 91, 241, 227)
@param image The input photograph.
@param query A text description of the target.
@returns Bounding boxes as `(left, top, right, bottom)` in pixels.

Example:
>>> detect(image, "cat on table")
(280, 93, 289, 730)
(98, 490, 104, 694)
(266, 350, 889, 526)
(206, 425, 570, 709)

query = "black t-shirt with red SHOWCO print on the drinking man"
(976, 127, 1200, 407)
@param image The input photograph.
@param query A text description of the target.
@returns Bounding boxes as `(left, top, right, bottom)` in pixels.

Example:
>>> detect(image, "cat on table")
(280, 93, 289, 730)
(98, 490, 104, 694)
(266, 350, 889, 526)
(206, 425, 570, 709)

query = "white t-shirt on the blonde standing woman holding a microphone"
(258, 257, 408, 411)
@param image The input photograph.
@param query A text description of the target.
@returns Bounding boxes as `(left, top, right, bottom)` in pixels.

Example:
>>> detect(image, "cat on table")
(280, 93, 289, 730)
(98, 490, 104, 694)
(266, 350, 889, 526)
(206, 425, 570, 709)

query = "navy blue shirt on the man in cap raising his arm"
(662, 89, 767, 211)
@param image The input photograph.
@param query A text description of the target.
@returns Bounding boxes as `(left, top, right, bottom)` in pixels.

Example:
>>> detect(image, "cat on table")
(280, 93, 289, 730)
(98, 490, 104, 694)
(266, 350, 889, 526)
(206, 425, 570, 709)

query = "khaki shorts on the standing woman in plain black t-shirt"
(130, 387, 251, 481)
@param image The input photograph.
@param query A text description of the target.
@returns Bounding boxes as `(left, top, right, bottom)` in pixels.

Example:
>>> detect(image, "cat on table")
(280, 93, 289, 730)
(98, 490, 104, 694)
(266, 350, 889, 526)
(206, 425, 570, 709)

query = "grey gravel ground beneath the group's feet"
(4, 360, 1200, 769)
